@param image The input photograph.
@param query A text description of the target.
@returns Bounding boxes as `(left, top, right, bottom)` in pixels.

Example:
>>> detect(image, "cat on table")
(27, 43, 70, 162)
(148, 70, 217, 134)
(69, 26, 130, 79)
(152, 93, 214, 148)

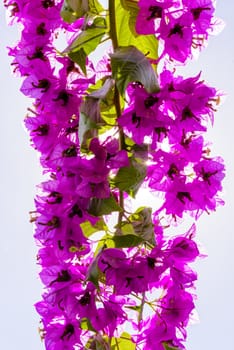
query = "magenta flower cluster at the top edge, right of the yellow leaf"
(136, 0, 216, 63)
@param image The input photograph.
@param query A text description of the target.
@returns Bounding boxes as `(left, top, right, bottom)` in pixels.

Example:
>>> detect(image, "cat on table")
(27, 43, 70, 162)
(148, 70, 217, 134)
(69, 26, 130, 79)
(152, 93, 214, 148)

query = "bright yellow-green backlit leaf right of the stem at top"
(115, 0, 158, 60)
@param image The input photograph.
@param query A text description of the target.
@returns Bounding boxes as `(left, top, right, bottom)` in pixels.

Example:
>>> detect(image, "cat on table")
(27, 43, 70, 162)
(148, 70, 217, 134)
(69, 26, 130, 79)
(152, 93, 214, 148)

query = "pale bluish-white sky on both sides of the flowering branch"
(0, 0, 234, 350)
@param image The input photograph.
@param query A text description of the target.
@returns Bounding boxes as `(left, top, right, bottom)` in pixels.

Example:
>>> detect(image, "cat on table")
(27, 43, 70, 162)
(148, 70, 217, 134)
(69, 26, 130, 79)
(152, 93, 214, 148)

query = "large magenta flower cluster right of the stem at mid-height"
(118, 70, 224, 217)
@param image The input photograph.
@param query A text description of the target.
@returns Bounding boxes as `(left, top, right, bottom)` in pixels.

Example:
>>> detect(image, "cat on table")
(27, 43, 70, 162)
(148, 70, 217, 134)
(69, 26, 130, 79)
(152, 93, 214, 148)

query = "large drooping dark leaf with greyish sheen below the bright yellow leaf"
(110, 46, 159, 96)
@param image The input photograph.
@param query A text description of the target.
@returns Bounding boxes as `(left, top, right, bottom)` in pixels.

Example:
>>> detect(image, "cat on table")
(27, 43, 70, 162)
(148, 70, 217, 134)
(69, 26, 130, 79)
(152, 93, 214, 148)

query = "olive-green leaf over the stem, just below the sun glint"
(111, 159, 146, 197)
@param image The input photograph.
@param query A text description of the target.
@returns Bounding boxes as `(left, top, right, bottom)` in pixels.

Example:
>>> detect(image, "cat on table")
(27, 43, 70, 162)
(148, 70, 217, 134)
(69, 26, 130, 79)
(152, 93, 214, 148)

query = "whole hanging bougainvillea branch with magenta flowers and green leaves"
(4, 0, 224, 350)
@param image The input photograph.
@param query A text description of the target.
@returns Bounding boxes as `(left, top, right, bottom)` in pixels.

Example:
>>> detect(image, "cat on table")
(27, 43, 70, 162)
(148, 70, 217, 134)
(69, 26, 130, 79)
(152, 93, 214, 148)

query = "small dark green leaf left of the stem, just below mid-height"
(88, 195, 122, 216)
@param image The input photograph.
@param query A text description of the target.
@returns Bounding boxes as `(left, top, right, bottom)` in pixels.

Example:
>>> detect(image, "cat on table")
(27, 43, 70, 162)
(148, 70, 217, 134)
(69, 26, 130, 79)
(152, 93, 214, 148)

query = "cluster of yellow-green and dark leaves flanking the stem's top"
(61, 0, 158, 86)
